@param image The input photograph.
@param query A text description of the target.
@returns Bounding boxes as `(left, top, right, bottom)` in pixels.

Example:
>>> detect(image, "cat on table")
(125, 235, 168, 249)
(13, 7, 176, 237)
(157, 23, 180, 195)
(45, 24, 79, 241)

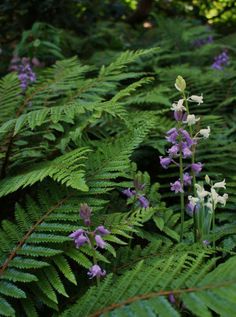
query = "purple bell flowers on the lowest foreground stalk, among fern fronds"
(69, 204, 110, 278)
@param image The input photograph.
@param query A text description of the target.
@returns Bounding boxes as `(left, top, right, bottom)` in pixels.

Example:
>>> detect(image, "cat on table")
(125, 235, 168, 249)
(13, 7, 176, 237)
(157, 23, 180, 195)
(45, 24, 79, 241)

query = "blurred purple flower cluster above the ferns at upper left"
(9, 56, 40, 91)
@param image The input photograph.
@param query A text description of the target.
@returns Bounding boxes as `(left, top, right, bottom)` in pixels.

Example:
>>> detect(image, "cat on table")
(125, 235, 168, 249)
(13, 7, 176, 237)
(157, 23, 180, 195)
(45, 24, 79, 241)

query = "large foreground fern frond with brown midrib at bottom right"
(59, 246, 236, 317)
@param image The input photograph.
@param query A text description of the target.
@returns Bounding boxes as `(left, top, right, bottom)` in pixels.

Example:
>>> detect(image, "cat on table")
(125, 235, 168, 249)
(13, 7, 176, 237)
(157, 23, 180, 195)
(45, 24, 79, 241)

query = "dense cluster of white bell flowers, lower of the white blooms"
(188, 175, 228, 213)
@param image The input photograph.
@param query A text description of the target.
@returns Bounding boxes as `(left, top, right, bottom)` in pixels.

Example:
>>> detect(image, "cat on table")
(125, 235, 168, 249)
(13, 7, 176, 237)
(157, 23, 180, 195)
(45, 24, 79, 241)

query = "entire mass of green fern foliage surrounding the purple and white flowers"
(0, 9, 236, 317)
